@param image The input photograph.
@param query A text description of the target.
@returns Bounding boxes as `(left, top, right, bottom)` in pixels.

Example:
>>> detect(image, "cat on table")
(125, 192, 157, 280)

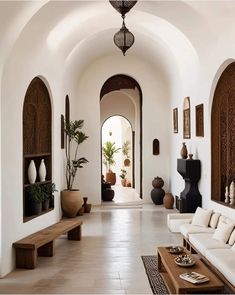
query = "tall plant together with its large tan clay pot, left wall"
(61, 120, 88, 217)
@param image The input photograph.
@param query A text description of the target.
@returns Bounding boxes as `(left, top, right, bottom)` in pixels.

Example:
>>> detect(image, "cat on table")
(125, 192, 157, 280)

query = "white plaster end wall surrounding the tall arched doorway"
(72, 55, 170, 204)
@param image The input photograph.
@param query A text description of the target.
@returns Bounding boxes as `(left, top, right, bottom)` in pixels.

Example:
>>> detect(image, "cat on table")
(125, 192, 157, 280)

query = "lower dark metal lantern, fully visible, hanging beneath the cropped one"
(113, 19, 135, 56)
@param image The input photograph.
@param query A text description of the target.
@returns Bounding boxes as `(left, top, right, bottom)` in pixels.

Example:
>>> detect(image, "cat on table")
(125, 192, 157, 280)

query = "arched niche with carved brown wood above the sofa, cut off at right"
(211, 62, 235, 208)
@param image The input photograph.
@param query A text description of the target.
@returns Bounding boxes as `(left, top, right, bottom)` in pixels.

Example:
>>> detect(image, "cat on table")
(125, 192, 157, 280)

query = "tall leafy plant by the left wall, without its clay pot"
(64, 120, 88, 190)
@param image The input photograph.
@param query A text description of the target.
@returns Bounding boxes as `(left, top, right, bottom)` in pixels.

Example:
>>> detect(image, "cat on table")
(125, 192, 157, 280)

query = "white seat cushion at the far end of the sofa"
(189, 233, 231, 256)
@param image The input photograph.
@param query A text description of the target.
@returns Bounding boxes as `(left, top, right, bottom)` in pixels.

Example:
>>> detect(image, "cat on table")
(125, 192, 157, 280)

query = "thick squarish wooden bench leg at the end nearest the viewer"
(16, 248, 37, 269)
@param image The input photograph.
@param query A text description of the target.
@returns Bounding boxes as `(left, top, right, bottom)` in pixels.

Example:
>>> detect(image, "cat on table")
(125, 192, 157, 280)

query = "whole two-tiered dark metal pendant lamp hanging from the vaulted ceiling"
(109, 0, 137, 56)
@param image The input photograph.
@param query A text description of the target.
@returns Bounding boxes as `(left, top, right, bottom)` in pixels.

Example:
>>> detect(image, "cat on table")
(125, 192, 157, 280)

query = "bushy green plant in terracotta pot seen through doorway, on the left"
(102, 141, 120, 185)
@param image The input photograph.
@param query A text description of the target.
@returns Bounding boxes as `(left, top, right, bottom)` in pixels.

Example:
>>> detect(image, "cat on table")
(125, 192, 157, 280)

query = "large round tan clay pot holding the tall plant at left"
(61, 190, 83, 217)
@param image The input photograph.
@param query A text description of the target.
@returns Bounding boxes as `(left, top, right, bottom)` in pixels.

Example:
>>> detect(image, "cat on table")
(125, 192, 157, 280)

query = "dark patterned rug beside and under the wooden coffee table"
(141, 255, 169, 294)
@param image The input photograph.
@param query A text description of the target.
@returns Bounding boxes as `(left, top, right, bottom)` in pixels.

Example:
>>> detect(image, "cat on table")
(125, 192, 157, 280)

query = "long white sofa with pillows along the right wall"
(176, 208, 235, 293)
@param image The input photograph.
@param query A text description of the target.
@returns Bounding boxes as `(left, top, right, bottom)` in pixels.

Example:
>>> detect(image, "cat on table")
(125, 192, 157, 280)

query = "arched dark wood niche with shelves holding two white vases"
(23, 77, 54, 222)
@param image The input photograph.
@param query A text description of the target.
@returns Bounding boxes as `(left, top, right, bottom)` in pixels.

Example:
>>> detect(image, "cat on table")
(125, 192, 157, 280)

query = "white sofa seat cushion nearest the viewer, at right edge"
(205, 247, 235, 286)
